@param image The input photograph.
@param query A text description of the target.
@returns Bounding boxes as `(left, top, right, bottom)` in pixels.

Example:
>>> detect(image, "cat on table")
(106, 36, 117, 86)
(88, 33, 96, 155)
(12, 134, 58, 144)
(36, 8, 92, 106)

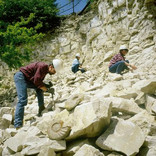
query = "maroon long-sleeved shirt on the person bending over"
(20, 62, 49, 88)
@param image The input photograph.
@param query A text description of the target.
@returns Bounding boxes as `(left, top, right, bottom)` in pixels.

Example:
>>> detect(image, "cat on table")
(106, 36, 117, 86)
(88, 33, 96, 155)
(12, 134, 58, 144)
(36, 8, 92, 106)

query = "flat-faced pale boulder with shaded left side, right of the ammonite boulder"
(96, 119, 145, 156)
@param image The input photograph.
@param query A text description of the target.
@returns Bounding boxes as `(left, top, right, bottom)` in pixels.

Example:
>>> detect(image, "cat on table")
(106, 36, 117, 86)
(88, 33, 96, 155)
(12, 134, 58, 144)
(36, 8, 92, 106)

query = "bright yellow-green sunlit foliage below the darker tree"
(0, 14, 44, 68)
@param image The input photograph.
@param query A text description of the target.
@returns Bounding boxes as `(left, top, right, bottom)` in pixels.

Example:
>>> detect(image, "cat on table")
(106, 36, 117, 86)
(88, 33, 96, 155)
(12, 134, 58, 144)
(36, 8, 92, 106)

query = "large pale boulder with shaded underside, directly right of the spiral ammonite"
(66, 99, 111, 140)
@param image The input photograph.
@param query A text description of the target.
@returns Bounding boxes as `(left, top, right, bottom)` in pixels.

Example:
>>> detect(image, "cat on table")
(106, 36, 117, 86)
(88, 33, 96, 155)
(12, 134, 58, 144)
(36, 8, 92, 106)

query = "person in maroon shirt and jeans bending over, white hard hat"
(14, 59, 63, 129)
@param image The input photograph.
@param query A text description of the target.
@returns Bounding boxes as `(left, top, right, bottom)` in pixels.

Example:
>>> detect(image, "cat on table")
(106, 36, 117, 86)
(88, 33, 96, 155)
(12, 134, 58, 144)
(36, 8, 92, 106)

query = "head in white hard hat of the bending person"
(49, 59, 63, 75)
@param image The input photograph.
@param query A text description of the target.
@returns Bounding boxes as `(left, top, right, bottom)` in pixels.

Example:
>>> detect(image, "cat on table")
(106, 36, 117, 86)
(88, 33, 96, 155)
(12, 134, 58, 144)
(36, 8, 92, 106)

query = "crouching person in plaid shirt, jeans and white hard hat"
(109, 45, 137, 74)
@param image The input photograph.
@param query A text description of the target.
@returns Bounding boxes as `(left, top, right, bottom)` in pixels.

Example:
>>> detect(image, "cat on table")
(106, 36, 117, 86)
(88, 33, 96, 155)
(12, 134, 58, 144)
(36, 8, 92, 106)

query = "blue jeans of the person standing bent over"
(14, 71, 44, 128)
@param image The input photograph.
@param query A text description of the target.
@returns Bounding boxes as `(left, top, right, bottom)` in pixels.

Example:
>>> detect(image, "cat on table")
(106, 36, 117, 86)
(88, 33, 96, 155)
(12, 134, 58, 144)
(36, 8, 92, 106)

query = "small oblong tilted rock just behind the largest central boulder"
(65, 93, 84, 111)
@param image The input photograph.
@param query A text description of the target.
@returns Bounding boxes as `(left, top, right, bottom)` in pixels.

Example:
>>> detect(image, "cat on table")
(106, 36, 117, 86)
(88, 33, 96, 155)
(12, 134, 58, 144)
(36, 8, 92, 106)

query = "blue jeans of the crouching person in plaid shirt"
(109, 60, 129, 74)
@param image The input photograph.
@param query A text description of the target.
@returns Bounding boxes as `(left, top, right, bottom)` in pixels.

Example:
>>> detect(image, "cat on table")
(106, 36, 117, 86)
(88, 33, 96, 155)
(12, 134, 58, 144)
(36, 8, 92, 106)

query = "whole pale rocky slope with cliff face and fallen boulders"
(0, 0, 156, 156)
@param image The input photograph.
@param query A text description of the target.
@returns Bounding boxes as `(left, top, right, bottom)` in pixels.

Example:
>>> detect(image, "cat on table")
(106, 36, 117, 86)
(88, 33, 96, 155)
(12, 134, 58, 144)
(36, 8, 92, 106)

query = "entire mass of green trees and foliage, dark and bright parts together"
(0, 0, 60, 68)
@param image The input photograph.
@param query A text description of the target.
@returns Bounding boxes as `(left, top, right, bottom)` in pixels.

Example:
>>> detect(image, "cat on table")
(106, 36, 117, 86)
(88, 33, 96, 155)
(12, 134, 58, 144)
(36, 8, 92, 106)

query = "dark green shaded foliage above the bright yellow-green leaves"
(0, 0, 59, 31)
